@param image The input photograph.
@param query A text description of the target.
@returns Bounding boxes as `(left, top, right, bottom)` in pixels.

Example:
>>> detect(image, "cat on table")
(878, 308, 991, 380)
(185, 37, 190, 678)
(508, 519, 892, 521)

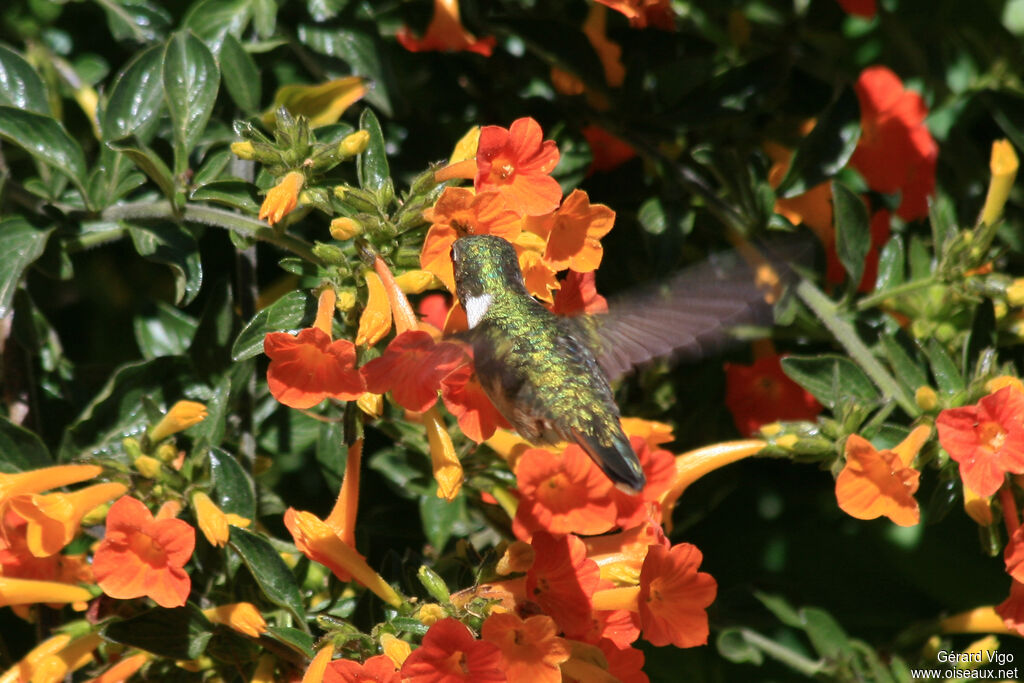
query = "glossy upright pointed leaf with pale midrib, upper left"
(163, 31, 220, 170)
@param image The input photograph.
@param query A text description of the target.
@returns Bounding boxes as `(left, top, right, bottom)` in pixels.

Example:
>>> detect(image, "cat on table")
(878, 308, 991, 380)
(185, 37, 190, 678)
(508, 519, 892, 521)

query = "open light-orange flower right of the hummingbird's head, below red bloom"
(525, 189, 615, 272)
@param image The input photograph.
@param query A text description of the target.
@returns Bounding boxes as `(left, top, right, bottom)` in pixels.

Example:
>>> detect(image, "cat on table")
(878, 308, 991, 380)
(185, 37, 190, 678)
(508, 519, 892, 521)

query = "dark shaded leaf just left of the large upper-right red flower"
(775, 87, 860, 198)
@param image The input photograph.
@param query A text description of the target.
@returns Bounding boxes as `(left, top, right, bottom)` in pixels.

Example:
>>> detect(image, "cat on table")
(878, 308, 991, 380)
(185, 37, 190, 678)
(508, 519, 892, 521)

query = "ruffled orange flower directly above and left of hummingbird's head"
(420, 187, 524, 292)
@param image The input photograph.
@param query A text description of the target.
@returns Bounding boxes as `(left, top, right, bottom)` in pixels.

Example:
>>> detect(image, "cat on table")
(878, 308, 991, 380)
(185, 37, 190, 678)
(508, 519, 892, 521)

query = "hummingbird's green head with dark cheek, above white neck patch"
(452, 234, 526, 306)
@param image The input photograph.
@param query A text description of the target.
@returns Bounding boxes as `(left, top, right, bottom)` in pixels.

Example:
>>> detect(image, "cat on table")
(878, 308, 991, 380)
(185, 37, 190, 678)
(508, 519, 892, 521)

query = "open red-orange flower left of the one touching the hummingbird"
(263, 328, 366, 409)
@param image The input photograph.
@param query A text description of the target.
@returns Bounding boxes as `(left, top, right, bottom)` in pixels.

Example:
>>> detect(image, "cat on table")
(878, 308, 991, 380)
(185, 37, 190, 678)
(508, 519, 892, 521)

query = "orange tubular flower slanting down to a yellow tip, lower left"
(285, 508, 401, 607)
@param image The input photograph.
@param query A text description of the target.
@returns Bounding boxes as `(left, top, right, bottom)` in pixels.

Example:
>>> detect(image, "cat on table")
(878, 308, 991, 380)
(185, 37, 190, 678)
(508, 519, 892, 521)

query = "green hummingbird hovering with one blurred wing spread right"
(452, 234, 771, 494)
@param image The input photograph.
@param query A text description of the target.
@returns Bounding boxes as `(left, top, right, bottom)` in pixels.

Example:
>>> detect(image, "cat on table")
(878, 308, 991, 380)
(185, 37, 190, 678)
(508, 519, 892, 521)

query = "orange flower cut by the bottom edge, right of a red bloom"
(480, 612, 569, 683)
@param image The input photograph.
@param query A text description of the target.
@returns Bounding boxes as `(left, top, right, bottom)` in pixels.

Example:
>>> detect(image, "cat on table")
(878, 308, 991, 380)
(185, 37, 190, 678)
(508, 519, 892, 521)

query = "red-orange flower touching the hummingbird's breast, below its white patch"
(360, 330, 466, 413)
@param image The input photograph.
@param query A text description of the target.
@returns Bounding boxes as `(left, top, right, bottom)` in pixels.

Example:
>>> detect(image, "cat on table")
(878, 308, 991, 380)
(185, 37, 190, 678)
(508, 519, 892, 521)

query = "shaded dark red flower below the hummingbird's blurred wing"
(725, 354, 821, 436)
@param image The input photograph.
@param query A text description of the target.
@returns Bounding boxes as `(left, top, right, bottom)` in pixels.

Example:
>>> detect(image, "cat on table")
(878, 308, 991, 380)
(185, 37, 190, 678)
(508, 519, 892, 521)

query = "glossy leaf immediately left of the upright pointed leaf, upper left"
(99, 45, 164, 144)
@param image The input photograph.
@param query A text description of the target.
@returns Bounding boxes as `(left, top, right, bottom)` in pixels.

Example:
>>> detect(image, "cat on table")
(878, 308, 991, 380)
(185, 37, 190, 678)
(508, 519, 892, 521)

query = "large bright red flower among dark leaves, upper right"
(850, 67, 939, 220)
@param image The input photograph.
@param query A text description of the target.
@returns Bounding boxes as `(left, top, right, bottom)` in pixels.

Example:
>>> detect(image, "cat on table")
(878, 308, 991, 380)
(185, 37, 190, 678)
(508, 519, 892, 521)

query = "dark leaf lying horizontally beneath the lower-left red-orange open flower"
(102, 603, 213, 659)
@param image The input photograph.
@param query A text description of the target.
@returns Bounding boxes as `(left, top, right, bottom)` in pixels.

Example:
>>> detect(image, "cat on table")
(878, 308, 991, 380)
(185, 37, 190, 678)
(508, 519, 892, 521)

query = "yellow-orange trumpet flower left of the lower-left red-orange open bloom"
(10, 483, 128, 557)
